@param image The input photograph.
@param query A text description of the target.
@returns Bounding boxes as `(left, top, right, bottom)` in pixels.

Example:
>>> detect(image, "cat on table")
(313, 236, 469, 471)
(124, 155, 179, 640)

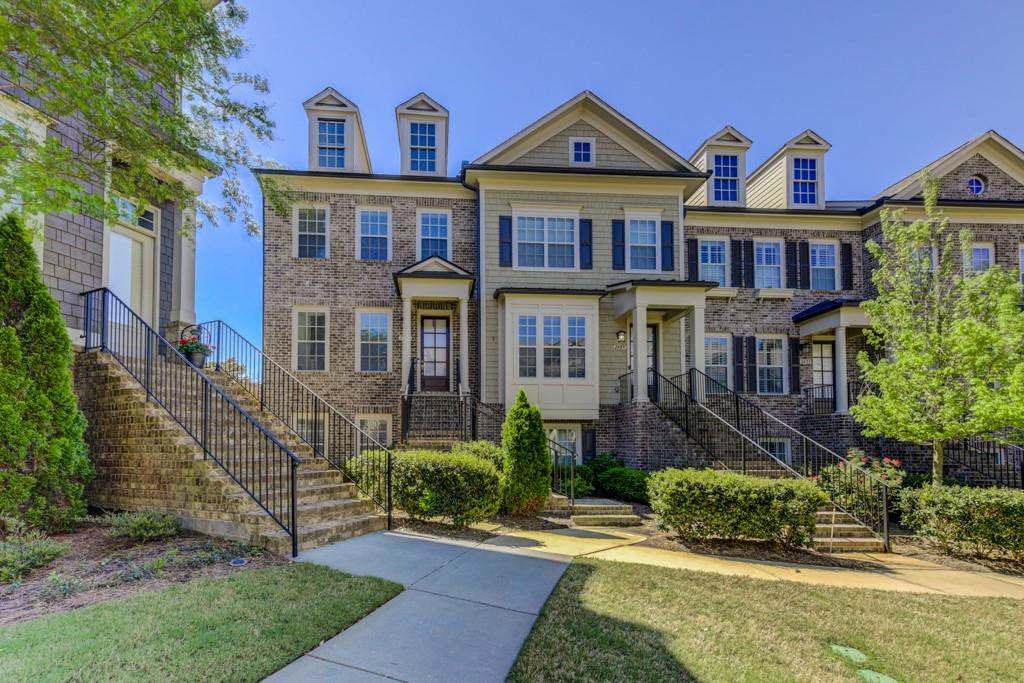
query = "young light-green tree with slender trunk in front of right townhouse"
(850, 177, 1024, 485)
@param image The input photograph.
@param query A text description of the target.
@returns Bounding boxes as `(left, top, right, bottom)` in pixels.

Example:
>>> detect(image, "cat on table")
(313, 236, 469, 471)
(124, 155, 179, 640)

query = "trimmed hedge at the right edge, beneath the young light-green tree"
(899, 485, 1024, 559)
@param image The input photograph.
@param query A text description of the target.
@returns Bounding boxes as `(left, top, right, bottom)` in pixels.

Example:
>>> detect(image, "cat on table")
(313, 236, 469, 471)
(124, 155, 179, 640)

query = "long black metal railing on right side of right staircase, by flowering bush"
(675, 368, 891, 549)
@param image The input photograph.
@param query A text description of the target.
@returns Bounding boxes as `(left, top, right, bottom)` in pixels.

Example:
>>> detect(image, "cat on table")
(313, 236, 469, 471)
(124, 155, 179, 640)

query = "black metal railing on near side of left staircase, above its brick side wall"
(83, 288, 302, 557)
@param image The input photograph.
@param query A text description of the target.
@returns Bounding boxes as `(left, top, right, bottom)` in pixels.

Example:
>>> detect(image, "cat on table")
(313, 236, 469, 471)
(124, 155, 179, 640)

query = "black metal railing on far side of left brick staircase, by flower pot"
(199, 321, 392, 528)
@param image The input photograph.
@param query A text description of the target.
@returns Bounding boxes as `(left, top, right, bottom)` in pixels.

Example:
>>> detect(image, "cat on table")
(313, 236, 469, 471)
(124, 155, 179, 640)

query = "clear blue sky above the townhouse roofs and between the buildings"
(197, 0, 1024, 343)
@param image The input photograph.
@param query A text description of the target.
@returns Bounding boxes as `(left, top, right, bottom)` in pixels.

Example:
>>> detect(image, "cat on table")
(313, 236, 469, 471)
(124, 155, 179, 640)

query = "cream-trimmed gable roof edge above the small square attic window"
(473, 90, 698, 172)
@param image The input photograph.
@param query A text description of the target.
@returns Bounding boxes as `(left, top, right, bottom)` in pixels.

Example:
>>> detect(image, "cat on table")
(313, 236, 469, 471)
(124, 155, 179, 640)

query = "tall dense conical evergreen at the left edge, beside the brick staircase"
(0, 215, 92, 529)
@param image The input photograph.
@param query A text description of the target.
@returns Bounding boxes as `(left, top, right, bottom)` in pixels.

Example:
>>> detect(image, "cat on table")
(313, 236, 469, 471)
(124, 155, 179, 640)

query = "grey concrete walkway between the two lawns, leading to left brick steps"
(267, 531, 572, 683)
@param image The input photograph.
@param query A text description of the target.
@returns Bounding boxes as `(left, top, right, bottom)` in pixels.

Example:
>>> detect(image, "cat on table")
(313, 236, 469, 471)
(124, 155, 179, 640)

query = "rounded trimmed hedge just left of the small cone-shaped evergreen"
(391, 451, 501, 526)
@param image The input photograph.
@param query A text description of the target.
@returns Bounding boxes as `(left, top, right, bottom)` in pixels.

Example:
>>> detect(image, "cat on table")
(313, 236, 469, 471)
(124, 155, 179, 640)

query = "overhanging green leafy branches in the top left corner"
(0, 0, 284, 233)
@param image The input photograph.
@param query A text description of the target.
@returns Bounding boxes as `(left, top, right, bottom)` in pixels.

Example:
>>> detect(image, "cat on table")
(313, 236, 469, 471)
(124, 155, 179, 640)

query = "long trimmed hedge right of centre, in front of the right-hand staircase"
(648, 469, 828, 546)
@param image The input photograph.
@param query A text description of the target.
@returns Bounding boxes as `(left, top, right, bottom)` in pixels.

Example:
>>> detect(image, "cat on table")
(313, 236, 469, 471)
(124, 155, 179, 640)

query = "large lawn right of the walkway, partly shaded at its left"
(509, 559, 1024, 683)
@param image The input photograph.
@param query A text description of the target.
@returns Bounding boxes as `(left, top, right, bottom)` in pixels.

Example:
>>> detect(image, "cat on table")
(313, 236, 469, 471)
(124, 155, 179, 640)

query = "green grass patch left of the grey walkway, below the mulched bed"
(0, 563, 401, 682)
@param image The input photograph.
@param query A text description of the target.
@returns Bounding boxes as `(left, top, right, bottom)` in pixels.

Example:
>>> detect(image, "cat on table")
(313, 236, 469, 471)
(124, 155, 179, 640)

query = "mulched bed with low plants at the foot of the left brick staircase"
(0, 522, 289, 626)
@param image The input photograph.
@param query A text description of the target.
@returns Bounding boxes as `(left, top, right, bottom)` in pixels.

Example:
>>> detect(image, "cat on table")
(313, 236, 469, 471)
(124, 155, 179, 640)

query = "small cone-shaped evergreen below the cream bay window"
(502, 389, 551, 515)
